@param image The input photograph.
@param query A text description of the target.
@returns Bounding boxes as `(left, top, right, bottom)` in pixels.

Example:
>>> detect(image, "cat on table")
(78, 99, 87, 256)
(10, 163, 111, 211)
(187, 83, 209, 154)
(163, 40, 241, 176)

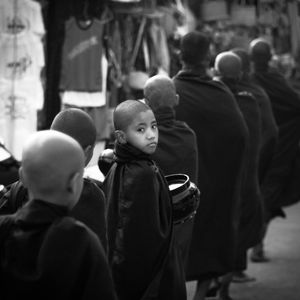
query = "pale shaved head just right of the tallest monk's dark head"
(215, 51, 242, 79)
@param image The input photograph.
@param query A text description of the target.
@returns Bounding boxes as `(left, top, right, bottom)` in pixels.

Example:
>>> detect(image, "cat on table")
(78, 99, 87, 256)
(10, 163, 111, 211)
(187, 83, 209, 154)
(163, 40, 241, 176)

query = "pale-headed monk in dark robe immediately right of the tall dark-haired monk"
(215, 51, 263, 299)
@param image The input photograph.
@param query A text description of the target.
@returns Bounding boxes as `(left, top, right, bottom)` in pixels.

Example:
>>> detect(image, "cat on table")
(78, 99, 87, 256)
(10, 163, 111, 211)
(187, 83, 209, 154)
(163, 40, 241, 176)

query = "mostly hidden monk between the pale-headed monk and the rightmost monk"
(232, 48, 278, 262)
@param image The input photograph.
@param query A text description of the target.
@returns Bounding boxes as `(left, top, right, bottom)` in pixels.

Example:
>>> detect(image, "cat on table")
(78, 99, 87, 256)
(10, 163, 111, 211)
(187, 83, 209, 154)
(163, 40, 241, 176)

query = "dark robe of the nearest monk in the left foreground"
(0, 200, 116, 300)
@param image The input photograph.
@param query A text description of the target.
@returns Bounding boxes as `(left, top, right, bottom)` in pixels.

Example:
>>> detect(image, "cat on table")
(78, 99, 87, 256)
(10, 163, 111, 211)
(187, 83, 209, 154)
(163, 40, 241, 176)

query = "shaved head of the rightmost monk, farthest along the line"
(249, 38, 272, 64)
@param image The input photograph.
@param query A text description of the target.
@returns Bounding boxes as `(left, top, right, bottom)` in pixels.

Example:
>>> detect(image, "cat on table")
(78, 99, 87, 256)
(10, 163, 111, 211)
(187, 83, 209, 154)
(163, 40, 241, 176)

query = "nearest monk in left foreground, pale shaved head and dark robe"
(0, 130, 116, 300)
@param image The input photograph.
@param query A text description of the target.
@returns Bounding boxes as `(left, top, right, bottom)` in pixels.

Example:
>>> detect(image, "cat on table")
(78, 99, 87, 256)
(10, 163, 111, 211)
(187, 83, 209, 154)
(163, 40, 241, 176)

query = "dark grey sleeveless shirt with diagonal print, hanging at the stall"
(60, 17, 104, 92)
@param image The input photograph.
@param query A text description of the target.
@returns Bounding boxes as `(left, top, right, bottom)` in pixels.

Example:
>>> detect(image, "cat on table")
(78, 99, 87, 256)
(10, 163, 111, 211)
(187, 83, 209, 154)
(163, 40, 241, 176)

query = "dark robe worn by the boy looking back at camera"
(103, 143, 186, 300)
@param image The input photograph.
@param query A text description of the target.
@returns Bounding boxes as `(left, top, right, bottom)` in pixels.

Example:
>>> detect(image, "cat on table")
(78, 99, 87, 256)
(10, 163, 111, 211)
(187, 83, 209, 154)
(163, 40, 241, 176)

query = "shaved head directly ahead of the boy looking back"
(144, 75, 179, 112)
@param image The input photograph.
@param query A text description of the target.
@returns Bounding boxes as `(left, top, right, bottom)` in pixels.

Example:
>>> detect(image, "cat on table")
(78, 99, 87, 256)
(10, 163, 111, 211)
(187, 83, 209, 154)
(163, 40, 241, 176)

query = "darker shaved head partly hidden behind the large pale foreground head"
(50, 108, 97, 165)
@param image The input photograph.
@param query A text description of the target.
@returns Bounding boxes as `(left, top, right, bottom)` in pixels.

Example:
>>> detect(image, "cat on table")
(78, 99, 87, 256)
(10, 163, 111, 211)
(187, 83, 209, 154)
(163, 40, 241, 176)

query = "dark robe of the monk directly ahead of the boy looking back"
(152, 107, 198, 266)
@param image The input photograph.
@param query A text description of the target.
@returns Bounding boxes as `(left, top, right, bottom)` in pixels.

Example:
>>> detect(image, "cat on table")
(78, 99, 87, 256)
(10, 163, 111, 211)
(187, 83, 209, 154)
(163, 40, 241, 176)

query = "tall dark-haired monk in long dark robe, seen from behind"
(173, 32, 248, 300)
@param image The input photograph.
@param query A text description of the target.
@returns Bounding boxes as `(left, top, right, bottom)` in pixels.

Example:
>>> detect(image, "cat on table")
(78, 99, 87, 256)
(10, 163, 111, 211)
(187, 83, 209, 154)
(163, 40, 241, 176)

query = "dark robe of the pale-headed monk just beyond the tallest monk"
(218, 80, 264, 270)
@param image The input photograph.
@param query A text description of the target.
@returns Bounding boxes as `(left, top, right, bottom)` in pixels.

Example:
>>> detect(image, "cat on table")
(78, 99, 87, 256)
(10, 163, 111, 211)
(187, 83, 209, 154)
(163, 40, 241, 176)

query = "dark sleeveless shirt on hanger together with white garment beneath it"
(59, 0, 112, 140)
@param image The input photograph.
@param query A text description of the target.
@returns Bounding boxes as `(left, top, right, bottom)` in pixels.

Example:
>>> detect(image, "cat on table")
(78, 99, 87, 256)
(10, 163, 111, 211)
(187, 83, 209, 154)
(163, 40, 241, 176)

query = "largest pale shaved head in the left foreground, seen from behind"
(19, 130, 84, 209)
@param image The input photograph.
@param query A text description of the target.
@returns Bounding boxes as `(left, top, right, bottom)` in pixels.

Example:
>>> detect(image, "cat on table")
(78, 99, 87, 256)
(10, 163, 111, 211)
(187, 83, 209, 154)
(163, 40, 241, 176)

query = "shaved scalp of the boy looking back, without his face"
(113, 100, 151, 131)
